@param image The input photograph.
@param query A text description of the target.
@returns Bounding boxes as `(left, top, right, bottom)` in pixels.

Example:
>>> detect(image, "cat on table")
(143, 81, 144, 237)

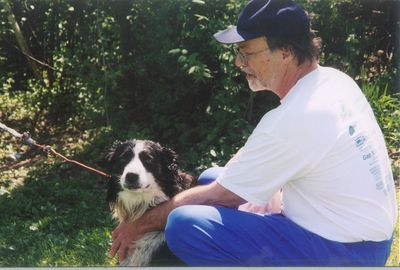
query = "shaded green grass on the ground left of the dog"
(0, 162, 115, 267)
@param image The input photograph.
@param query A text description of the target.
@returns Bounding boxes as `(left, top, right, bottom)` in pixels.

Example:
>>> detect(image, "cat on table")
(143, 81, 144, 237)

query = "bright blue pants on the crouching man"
(165, 168, 392, 266)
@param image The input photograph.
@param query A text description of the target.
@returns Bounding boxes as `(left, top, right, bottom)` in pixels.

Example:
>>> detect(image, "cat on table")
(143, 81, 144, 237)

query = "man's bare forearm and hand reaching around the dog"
(110, 182, 245, 261)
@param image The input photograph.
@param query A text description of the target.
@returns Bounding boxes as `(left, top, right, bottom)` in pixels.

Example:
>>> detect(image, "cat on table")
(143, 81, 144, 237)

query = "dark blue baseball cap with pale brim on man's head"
(214, 0, 310, 44)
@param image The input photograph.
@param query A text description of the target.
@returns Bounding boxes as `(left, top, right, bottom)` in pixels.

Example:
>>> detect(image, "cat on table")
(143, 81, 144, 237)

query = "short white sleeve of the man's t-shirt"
(217, 132, 308, 205)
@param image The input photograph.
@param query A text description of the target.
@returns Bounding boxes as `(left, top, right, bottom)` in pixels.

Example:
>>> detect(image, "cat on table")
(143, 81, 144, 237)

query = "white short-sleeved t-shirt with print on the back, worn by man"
(217, 66, 397, 242)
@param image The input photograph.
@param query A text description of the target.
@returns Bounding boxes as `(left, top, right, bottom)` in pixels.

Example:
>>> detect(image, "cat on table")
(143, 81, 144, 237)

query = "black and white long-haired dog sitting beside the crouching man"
(105, 140, 195, 266)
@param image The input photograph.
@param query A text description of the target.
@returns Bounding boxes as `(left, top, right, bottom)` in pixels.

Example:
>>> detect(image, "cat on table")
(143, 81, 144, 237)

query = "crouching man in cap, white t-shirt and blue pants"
(110, 0, 397, 266)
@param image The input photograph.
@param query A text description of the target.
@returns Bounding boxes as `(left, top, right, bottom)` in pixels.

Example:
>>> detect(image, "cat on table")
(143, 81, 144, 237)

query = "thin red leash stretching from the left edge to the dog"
(0, 123, 112, 177)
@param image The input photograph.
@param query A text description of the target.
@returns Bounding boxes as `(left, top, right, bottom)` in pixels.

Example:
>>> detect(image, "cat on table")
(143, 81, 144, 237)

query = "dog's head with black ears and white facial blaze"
(105, 140, 190, 205)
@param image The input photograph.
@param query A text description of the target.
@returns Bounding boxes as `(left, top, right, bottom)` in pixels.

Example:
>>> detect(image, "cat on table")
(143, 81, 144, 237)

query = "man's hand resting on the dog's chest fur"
(109, 222, 141, 262)
